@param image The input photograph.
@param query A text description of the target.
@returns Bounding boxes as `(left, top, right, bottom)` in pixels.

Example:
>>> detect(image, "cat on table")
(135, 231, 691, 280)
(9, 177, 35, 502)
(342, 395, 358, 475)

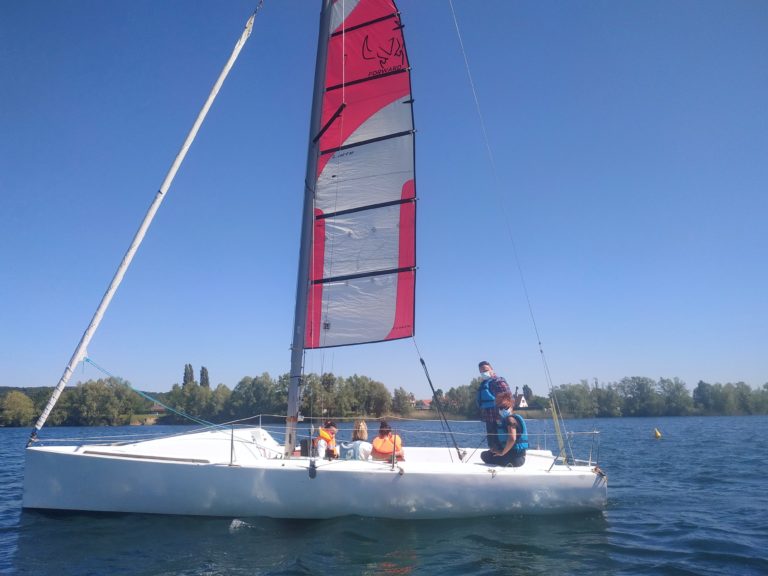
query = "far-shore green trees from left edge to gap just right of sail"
(0, 364, 415, 426)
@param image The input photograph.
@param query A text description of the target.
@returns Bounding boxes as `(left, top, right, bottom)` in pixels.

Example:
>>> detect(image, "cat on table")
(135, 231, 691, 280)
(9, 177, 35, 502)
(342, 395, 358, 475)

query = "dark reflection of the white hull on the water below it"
(9, 512, 619, 576)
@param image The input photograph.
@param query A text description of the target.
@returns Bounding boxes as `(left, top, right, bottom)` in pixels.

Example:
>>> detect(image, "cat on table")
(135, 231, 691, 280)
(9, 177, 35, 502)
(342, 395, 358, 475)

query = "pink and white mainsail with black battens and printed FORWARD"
(305, 0, 416, 348)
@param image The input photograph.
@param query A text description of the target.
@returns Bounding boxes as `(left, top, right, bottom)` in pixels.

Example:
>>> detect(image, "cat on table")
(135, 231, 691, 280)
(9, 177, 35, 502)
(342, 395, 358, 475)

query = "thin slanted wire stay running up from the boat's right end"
(448, 0, 565, 454)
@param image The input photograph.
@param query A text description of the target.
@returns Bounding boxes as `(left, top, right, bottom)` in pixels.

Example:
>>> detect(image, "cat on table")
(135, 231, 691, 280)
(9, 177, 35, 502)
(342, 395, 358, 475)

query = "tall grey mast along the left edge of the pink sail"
(284, 0, 333, 458)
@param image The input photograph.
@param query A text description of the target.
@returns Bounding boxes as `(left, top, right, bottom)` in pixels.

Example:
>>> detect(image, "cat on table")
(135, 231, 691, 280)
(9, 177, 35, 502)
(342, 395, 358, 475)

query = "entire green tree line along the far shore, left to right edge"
(0, 364, 768, 426)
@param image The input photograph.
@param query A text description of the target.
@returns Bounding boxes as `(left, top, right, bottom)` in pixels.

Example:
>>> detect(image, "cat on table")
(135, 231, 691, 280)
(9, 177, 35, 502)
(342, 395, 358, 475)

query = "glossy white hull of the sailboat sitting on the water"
(23, 428, 607, 519)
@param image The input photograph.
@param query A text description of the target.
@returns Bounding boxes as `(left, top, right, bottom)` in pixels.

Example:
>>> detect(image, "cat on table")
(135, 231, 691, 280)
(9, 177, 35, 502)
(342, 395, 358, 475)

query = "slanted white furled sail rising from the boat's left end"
(27, 11, 261, 446)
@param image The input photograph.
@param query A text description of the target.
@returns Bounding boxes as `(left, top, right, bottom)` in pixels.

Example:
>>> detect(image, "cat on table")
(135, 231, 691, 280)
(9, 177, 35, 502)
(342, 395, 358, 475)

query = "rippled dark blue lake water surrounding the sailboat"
(0, 417, 768, 576)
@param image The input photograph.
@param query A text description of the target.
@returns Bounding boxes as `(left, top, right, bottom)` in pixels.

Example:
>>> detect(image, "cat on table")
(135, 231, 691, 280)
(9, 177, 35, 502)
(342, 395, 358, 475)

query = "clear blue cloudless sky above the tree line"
(0, 0, 768, 397)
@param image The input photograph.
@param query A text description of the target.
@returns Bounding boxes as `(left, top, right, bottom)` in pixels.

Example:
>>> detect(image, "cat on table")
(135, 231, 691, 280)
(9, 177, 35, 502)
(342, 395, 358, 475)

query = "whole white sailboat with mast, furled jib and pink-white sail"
(23, 0, 607, 519)
